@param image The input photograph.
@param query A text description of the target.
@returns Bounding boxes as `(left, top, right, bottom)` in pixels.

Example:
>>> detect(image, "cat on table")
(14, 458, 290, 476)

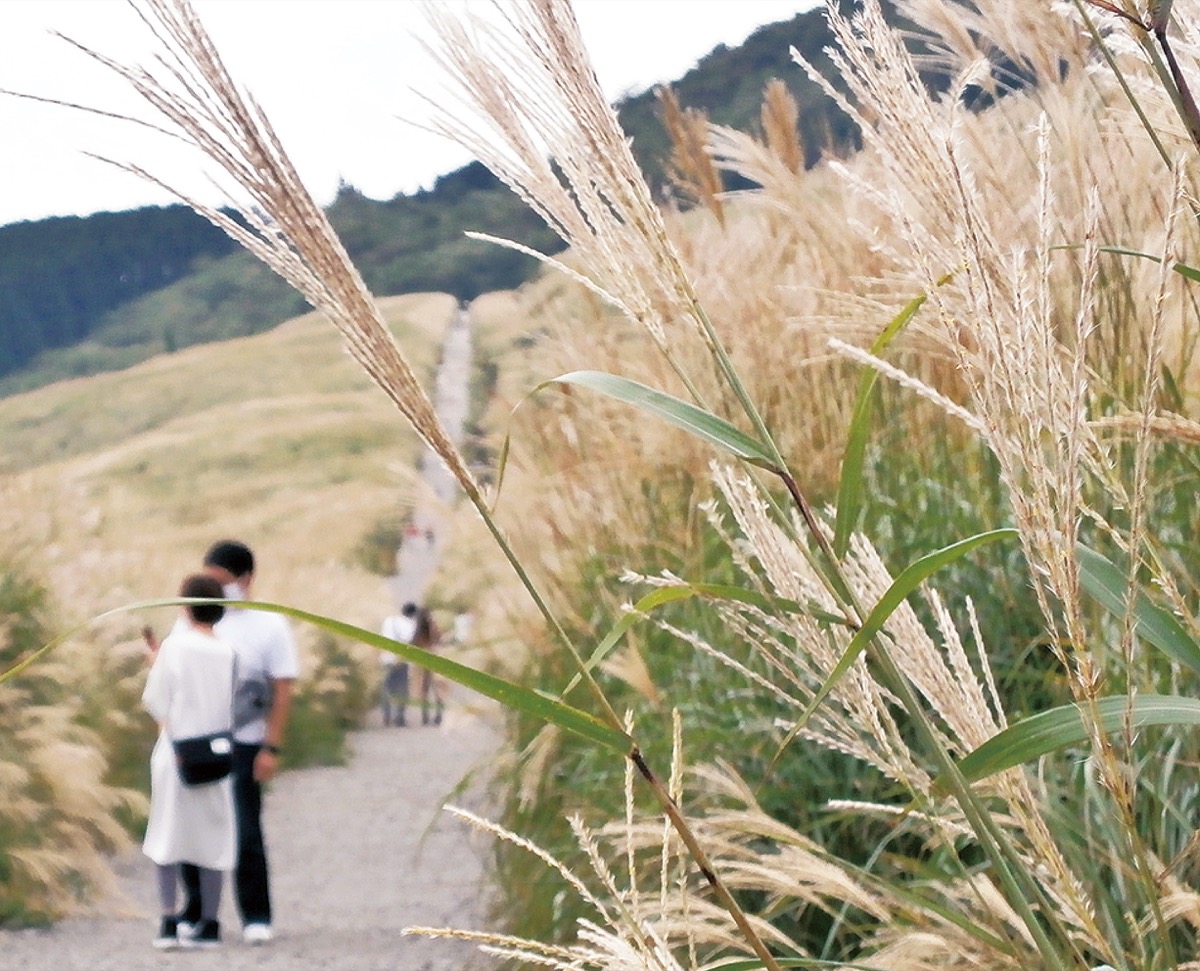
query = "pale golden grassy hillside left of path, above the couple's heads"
(0, 288, 455, 648)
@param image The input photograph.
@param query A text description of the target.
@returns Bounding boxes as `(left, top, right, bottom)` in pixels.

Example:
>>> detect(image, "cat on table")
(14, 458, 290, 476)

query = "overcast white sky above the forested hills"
(0, 0, 817, 226)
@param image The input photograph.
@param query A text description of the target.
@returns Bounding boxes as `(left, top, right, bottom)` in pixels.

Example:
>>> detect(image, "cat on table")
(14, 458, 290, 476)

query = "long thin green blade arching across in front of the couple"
(0, 598, 634, 755)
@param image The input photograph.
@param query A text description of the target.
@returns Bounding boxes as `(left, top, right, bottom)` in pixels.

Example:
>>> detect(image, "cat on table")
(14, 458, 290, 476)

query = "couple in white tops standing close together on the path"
(143, 540, 298, 949)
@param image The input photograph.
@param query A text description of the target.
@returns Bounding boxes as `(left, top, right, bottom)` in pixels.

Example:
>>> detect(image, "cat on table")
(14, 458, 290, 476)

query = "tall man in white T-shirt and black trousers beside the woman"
(180, 540, 299, 945)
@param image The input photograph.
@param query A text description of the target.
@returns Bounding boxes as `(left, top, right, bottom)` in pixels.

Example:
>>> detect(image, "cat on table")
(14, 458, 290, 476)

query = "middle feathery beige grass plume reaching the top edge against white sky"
(431, 0, 702, 349)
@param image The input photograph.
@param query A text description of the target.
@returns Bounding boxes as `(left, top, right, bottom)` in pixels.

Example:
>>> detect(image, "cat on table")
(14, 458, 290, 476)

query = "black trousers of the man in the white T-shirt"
(181, 742, 271, 925)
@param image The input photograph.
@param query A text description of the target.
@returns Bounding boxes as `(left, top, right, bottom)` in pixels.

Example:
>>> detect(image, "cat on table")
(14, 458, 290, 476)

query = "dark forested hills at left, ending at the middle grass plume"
(0, 163, 562, 394)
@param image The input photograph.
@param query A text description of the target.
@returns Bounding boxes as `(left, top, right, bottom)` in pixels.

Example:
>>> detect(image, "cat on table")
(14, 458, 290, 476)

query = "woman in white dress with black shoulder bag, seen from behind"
(142, 574, 235, 949)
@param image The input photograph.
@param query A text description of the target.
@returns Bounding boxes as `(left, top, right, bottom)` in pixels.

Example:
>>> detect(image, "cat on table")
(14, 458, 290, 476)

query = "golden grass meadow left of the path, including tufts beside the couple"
(0, 294, 456, 922)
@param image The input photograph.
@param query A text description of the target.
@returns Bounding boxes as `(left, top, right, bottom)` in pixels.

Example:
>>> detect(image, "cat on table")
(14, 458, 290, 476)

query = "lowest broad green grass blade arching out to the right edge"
(955, 695, 1200, 785)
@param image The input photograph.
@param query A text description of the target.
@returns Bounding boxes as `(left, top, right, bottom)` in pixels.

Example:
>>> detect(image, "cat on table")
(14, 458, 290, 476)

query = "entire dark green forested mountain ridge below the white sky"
(0, 10, 847, 396)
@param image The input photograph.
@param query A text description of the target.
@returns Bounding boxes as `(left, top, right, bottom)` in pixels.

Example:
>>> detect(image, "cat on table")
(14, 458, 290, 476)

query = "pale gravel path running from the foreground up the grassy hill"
(0, 302, 499, 971)
